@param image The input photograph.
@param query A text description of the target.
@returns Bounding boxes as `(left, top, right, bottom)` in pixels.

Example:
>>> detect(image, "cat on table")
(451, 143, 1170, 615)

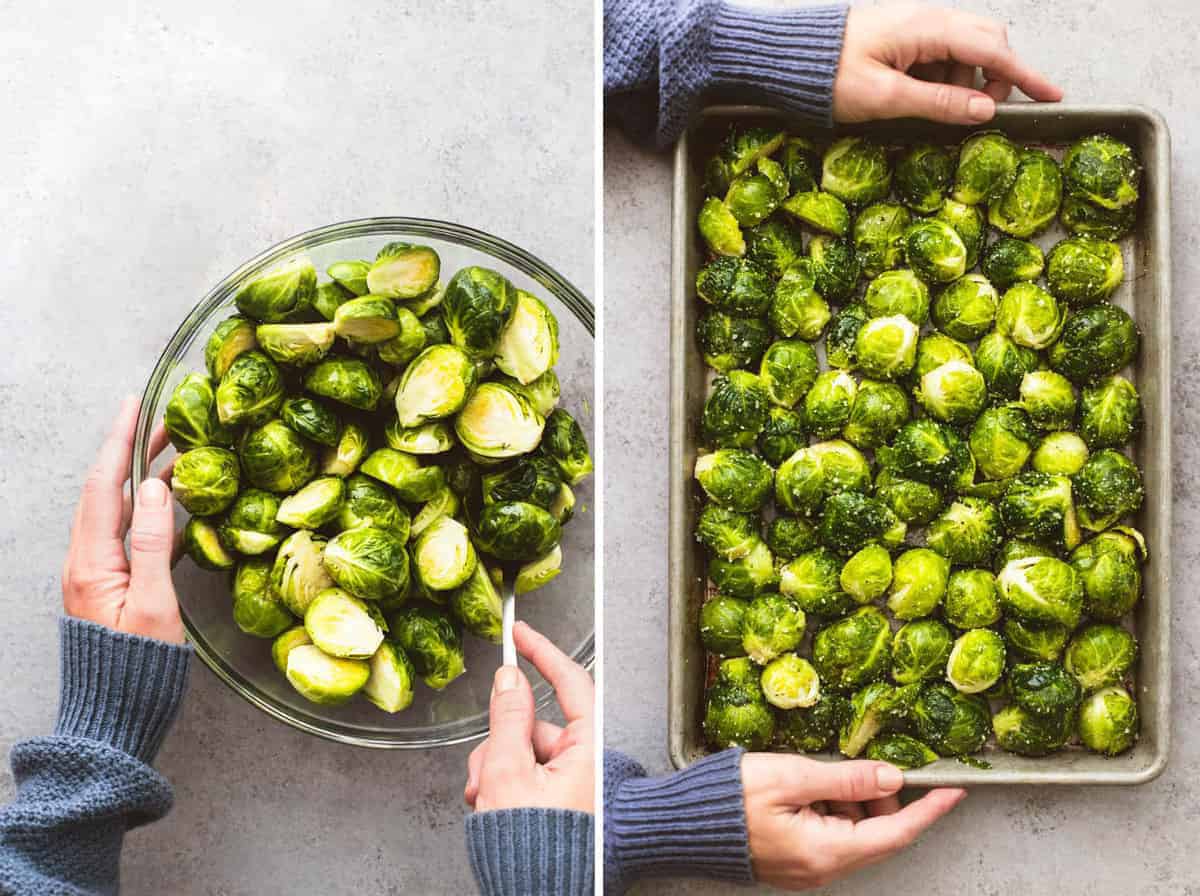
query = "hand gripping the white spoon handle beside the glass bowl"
(463, 623, 595, 812)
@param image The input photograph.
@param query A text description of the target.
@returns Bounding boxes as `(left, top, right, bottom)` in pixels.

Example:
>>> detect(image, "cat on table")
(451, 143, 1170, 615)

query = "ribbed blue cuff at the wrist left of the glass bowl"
(54, 617, 192, 763)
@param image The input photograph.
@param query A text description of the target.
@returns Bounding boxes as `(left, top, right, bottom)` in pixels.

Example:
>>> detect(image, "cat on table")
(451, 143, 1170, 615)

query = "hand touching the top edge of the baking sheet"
(833, 4, 1062, 125)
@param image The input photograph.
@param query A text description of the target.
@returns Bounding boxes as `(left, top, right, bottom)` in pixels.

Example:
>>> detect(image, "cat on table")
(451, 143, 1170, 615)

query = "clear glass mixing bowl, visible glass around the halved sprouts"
(132, 217, 595, 750)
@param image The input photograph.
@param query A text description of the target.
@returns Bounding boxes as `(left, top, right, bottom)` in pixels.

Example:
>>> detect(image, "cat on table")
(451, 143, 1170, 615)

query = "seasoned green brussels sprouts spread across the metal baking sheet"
(695, 127, 1147, 768)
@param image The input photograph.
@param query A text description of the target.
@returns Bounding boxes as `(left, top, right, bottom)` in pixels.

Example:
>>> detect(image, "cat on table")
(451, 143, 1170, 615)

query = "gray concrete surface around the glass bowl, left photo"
(0, 0, 594, 896)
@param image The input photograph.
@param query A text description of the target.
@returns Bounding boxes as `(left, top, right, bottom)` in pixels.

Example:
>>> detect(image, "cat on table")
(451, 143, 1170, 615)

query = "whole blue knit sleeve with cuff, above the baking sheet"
(604, 0, 847, 149)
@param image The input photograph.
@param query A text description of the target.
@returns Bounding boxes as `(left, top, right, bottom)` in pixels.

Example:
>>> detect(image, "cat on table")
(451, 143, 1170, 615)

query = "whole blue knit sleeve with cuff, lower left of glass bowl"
(0, 619, 192, 896)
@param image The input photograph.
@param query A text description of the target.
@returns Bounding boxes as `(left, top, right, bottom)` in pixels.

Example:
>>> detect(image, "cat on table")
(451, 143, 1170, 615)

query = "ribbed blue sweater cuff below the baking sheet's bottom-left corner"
(605, 748, 754, 883)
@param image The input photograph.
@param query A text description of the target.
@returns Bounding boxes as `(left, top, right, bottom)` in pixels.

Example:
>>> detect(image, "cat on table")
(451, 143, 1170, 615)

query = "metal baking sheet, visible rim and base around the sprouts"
(667, 103, 1171, 787)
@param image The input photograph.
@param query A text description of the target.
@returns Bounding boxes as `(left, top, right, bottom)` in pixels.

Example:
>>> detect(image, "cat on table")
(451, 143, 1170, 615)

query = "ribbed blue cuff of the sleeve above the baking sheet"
(707, 2, 848, 127)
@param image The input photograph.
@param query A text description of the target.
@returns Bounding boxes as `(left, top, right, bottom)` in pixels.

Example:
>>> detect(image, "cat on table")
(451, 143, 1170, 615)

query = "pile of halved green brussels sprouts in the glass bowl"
(163, 241, 592, 721)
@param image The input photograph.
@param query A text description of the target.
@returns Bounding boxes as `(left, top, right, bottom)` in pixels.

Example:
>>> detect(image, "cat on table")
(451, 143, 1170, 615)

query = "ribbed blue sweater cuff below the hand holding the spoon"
(467, 808, 595, 896)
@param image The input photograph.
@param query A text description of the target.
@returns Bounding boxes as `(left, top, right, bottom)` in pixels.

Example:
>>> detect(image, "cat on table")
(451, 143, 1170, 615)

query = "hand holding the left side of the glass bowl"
(62, 397, 184, 644)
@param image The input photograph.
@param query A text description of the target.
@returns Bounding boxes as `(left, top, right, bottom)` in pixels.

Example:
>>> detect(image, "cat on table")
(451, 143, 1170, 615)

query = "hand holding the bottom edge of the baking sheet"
(742, 753, 966, 890)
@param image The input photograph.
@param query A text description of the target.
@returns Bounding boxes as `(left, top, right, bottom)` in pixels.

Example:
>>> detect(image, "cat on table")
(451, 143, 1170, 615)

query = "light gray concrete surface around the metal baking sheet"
(605, 0, 1200, 896)
